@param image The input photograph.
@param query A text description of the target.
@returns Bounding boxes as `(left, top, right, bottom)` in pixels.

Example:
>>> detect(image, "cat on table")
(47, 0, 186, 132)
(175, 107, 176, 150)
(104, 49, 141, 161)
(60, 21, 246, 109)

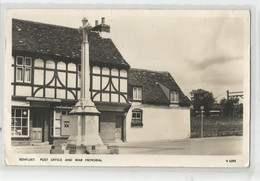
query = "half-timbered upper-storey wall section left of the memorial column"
(11, 54, 80, 99)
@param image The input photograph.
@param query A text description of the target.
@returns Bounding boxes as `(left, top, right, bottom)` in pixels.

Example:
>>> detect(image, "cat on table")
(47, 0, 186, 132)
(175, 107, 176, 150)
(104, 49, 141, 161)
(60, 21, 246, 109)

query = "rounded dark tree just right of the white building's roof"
(190, 89, 215, 116)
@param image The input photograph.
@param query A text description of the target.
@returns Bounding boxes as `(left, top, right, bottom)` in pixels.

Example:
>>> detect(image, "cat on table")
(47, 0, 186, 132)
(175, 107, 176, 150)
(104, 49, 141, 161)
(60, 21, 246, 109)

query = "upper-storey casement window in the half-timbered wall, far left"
(16, 56, 32, 82)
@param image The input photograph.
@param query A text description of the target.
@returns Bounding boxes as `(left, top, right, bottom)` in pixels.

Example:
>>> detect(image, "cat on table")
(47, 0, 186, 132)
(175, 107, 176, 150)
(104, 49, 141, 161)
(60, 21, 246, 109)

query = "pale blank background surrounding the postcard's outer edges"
(0, 0, 260, 180)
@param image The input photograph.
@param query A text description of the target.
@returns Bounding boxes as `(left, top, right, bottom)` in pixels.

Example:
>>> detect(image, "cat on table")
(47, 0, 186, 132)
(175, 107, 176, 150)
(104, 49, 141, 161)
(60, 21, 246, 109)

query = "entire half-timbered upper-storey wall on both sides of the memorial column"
(11, 55, 128, 103)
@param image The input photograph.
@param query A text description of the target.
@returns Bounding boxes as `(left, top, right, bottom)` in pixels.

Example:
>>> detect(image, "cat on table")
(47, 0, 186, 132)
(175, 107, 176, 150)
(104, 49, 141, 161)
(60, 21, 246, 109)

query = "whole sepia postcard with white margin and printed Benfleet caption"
(3, 9, 250, 167)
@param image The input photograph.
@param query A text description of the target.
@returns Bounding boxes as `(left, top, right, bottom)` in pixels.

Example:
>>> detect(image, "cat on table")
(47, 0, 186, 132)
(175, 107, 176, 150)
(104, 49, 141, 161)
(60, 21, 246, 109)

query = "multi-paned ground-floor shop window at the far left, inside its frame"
(11, 108, 29, 137)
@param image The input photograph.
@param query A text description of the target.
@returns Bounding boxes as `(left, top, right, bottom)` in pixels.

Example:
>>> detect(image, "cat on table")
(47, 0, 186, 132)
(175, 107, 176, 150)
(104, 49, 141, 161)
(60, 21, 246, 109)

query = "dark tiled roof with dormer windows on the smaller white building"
(128, 68, 190, 107)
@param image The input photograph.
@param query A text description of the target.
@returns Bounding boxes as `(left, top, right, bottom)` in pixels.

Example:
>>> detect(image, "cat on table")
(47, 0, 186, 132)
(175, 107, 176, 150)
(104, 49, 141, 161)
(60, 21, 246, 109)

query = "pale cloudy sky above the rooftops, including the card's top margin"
(8, 9, 249, 100)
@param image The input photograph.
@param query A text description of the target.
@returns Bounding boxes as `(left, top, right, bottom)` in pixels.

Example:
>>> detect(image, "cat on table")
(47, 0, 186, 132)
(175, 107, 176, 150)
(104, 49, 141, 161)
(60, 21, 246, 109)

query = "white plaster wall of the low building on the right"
(126, 104, 190, 142)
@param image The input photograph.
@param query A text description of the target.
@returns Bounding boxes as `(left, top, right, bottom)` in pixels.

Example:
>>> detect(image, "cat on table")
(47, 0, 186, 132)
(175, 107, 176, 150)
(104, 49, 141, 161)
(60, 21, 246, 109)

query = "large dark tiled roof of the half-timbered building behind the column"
(12, 19, 130, 69)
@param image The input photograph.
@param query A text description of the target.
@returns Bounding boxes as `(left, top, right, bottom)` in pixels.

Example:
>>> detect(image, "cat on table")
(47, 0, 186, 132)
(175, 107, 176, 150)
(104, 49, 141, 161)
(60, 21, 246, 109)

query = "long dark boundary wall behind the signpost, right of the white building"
(190, 116, 243, 138)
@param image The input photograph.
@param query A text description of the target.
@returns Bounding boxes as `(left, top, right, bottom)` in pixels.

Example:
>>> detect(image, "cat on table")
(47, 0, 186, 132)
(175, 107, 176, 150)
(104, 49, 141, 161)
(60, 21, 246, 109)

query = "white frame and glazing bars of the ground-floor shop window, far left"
(11, 107, 30, 138)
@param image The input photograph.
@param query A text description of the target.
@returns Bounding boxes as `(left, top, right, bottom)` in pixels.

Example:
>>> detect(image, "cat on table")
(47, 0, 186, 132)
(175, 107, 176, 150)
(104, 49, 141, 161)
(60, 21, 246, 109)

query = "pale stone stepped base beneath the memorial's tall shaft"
(66, 99, 118, 154)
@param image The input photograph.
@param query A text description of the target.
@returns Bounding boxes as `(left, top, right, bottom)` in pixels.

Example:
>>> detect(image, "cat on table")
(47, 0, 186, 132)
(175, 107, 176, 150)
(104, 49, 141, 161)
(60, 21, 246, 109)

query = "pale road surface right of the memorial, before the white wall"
(110, 136, 243, 155)
